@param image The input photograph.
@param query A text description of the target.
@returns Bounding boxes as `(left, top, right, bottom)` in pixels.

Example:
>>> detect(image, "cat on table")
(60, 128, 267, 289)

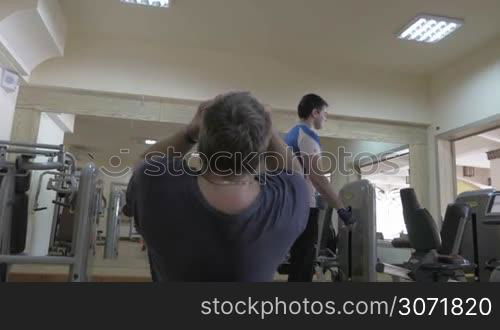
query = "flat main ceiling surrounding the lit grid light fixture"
(60, 0, 500, 74)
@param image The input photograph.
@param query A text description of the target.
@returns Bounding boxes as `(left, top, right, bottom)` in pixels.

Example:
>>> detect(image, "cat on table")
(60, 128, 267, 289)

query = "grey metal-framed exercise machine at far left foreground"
(0, 141, 101, 282)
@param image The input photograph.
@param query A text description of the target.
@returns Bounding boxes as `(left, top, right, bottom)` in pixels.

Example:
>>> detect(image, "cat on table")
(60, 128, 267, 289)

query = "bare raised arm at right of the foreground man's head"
(266, 130, 304, 174)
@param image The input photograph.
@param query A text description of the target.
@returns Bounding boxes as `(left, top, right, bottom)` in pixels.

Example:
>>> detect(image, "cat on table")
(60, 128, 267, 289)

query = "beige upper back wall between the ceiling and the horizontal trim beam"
(31, 39, 431, 123)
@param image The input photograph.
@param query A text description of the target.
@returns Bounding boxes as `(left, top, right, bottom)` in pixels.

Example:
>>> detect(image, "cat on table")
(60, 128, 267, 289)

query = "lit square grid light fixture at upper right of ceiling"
(398, 14, 464, 43)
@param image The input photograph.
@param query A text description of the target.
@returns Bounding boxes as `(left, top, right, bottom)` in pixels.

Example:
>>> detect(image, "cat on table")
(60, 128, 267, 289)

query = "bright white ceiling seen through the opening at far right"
(455, 128, 500, 168)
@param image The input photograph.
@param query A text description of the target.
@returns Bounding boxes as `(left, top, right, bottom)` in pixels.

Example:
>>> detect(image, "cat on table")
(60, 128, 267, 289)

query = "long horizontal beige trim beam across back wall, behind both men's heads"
(17, 87, 427, 145)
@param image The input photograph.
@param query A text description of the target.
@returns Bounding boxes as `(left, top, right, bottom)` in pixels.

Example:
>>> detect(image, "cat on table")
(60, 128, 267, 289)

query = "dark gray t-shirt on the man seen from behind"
(127, 159, 309, 282)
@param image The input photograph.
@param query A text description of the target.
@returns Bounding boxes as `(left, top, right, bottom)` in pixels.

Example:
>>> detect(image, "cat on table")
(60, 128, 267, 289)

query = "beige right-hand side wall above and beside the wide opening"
(429, 35, 500, 216)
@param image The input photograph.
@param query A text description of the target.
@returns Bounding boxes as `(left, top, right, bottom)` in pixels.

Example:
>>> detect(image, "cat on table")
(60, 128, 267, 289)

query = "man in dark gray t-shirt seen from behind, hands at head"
(127, 93, 309, 282)
